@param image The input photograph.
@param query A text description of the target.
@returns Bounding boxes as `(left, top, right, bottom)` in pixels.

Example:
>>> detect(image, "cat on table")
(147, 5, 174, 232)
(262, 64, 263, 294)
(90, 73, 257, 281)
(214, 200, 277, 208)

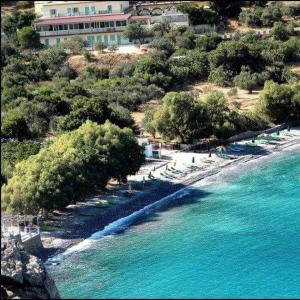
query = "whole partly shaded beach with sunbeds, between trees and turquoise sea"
(41, 127, 300, 260)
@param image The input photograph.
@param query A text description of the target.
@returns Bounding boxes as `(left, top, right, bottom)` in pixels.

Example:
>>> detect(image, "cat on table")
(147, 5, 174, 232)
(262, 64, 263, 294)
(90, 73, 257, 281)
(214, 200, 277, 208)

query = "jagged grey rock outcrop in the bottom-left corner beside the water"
(1, 240, 60, 299)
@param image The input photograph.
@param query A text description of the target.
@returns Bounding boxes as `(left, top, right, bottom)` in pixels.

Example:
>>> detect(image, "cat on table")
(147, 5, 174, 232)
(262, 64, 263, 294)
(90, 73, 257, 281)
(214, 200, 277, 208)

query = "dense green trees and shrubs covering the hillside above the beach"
(1, 1, 300, 212)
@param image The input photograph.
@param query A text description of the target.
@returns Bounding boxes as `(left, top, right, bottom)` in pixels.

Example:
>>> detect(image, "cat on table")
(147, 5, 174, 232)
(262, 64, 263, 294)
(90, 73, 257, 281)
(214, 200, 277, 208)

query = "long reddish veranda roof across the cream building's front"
(35, 13, 131, 25)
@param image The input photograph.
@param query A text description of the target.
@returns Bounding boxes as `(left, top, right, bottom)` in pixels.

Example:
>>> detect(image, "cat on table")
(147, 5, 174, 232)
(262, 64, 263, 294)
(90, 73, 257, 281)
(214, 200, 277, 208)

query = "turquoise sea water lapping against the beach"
(49, 154, 300, 298)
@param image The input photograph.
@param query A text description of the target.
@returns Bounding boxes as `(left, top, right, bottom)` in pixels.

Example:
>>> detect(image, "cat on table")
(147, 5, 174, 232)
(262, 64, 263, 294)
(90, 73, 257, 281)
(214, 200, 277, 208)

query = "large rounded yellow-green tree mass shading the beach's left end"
(2, 121, 144, 213)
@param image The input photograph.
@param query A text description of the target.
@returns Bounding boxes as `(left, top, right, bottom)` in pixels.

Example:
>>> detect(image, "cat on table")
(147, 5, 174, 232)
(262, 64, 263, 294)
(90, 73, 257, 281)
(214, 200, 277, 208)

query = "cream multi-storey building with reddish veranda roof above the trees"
(34, 1, 188, 48)
